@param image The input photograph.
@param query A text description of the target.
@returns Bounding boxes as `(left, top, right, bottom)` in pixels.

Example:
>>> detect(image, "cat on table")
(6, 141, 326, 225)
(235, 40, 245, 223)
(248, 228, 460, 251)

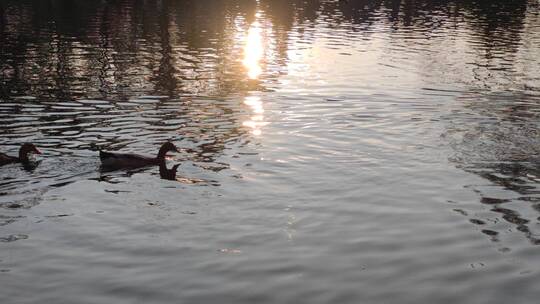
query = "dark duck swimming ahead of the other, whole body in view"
(99, 141, 184, 171)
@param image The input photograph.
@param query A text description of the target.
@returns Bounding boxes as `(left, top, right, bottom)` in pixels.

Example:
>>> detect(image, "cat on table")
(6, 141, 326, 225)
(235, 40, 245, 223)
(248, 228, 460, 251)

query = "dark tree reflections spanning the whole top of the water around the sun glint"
(0, 0, 528, 99)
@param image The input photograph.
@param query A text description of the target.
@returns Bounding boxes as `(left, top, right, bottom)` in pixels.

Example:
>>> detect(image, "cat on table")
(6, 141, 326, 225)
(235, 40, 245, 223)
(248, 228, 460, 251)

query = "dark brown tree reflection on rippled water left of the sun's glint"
(0, 1, 281, 99)
